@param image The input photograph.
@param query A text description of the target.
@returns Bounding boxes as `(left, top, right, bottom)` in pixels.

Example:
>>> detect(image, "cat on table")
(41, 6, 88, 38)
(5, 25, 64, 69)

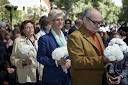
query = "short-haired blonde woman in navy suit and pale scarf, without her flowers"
(37, 9, 70, 85)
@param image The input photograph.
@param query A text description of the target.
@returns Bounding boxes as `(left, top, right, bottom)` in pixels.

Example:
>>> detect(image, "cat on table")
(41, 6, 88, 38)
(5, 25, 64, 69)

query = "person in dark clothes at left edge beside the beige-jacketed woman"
(0, 29, 16, 85)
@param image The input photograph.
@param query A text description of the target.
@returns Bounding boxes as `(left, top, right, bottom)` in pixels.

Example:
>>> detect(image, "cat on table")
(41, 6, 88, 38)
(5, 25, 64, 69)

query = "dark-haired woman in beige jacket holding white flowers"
(11, 20, 37, 85)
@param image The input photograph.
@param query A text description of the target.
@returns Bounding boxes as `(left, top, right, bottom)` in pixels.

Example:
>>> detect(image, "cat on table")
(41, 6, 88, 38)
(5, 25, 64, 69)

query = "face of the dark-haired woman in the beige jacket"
(23, 23, 34, 36)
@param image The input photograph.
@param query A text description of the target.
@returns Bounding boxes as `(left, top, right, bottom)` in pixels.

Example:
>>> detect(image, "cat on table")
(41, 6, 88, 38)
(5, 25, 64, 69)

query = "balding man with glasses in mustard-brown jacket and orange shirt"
(68, 8, 104, 85)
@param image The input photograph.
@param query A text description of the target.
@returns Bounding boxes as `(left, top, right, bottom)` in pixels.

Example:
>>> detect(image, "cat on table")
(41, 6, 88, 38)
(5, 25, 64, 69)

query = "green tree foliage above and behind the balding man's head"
(54, 0, 121, 23)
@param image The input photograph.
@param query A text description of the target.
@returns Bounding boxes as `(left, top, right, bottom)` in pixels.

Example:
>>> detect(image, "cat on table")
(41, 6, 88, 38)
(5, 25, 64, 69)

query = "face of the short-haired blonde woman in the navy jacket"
(53, 16, 64, 30)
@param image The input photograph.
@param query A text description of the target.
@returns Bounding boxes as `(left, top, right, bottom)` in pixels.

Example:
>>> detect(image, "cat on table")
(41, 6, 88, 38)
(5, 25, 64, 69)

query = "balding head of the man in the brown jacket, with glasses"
(82, 8, 103, 33)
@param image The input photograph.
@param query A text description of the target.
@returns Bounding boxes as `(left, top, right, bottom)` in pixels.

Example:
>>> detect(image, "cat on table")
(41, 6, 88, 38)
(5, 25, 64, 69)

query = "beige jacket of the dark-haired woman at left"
(10, 36, 38, 83)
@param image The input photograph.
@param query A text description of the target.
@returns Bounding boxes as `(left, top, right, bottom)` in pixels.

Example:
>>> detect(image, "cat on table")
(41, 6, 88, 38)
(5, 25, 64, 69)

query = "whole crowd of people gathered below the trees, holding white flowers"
(0, 8, 128, 85)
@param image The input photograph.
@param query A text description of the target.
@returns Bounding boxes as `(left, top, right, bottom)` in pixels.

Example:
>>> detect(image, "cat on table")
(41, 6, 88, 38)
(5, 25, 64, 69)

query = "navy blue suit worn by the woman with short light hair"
(37, 32, 69, 85)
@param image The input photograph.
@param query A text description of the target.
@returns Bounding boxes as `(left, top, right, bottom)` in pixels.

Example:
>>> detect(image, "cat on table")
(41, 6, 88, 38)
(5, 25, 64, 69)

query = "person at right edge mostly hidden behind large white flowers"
(104, 33, 128, 85)
